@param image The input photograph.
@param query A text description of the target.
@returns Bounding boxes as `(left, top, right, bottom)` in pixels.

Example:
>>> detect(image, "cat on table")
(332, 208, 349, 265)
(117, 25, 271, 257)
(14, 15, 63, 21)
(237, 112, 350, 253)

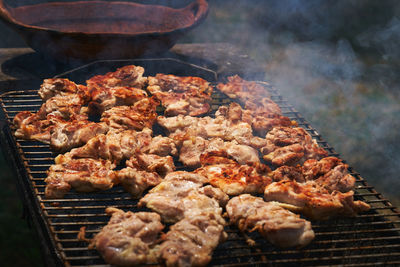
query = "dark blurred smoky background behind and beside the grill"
(0, 0, 400, 266)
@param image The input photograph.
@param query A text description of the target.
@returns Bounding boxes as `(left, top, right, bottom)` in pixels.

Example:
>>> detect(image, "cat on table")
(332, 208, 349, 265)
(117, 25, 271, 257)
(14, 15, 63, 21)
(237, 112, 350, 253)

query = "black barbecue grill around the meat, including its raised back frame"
(0, 58, 400, 266)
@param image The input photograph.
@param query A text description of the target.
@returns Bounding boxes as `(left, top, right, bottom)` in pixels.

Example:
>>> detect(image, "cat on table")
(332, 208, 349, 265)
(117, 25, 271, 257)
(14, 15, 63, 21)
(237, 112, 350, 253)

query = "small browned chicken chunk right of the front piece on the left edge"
(116, 167, 162, 198)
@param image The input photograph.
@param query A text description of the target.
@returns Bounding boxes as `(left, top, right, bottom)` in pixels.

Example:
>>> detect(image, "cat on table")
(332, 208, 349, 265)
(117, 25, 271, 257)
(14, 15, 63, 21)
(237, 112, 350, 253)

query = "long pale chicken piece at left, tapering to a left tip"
(56, 128, 152, 164)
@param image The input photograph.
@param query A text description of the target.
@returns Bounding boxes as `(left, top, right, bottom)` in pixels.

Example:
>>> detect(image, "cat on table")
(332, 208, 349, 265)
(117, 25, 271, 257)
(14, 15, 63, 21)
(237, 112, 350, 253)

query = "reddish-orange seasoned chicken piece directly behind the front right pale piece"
(196, 159, 272, 196)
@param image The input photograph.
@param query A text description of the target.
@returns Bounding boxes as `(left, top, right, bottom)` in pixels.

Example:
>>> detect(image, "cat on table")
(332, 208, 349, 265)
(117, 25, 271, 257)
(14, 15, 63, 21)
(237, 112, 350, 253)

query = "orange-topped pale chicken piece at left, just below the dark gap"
(50, 120, 108, 152)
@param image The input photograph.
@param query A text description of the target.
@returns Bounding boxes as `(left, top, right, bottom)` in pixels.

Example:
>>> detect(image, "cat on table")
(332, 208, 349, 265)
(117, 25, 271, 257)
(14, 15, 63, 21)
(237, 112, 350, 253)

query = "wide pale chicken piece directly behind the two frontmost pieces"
(139, 171, 222, 222)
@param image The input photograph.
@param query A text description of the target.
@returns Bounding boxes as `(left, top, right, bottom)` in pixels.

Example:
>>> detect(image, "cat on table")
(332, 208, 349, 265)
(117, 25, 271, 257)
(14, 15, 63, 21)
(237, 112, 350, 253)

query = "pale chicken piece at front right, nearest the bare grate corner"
(226, 194, 314, 248)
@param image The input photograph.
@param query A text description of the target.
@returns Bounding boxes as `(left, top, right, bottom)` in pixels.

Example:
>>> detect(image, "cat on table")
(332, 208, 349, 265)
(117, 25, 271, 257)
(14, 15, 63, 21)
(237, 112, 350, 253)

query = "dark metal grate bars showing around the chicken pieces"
(1, 83, 400, 266)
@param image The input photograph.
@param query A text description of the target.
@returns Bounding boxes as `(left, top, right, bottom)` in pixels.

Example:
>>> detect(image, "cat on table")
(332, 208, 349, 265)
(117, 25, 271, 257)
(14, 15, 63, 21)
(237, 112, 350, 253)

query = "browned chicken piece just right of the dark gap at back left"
(101, 98, 158, 130)
